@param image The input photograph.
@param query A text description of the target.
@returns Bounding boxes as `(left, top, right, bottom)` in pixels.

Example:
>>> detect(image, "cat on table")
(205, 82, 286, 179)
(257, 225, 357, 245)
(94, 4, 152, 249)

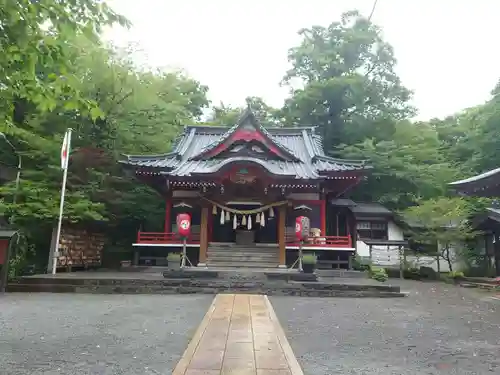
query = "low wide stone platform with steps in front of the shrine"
(7, 269, 405, 297)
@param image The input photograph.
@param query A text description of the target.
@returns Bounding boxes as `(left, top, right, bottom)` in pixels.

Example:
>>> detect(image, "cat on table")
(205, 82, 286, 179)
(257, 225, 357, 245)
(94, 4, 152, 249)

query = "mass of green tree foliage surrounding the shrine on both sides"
(0, 5, 500, 274)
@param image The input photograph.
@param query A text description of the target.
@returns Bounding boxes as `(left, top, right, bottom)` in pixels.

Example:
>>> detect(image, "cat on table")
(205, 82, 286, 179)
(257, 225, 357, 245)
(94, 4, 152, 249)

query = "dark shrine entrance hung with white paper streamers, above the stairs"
(211, 202, 278, 245)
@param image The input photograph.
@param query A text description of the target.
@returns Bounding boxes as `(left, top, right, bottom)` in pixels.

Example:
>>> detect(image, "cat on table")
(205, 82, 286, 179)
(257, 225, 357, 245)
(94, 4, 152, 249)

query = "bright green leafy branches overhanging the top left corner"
(0, 0, 127, 128)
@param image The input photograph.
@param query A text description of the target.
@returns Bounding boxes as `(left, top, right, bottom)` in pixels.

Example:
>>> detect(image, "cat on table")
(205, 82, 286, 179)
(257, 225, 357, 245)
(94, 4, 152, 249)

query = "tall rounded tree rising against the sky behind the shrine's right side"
(283, 12, 415, 151)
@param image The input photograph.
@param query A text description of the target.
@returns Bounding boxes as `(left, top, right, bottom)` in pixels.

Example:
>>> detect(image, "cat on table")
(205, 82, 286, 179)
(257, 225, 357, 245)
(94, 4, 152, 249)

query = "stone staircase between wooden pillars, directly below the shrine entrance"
(207, 243, 279, 268)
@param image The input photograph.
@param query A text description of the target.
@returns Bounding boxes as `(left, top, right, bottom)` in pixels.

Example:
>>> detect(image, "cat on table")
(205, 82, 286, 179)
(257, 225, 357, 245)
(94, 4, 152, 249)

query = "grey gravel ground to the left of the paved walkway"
(0, 294, 213, 375)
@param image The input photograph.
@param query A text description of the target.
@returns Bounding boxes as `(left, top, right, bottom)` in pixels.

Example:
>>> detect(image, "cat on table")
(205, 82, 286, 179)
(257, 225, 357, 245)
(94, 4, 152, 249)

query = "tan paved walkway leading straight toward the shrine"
(173, 294, 303, 375)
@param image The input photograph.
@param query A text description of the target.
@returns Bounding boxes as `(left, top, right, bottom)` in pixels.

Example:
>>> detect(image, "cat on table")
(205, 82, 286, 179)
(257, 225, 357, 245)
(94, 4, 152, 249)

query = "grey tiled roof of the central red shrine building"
(122, 114, 368, 179)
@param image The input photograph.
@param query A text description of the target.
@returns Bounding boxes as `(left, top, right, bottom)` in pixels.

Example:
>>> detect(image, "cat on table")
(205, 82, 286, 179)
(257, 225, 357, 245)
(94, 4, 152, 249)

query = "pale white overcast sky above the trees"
(106, 0, 500, 119)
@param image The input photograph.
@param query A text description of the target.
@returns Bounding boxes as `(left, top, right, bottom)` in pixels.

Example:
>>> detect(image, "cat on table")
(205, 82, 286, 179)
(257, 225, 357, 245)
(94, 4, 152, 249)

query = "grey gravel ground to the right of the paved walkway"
(270, 281, 500, 375)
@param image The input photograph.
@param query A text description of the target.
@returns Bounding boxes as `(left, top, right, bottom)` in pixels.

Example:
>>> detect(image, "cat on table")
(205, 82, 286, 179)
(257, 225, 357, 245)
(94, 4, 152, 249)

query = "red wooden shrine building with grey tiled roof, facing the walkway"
(121, 109, 369, 268)
